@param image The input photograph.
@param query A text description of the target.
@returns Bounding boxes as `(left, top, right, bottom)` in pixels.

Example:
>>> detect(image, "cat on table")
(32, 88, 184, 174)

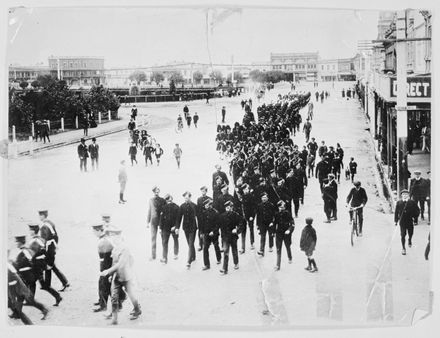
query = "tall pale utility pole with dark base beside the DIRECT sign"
(396, 10, 408, 197)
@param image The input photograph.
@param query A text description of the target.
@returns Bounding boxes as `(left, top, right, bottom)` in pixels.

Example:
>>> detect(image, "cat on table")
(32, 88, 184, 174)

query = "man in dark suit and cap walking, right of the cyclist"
(394, 189, 420, 255)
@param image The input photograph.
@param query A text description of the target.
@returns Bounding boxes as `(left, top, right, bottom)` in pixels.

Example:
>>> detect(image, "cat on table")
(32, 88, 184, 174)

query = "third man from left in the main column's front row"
(179, 191, 198, 269)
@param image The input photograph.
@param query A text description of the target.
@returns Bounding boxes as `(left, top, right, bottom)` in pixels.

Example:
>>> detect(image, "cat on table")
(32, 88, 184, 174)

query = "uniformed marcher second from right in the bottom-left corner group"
(28, 223, 62, 306)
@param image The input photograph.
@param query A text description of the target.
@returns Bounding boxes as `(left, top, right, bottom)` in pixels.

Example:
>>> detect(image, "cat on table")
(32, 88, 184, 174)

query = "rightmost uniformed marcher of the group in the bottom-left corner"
(38, 210, 70, 292)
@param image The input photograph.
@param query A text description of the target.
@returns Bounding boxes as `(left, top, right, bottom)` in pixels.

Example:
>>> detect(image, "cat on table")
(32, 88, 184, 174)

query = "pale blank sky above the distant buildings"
(7, 8, 378, 68)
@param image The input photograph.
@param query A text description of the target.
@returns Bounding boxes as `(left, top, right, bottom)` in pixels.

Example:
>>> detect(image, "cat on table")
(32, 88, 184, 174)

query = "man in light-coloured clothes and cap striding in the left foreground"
(101, 225, 142, 325)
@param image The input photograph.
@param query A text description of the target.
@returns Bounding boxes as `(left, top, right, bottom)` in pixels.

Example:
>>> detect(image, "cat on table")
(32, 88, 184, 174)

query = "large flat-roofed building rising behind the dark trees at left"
(49, 56, 105, 87)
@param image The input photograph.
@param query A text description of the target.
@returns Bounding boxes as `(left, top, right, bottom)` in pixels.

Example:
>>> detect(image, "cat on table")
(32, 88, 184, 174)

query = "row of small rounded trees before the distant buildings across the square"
(128, 70, 243, 85)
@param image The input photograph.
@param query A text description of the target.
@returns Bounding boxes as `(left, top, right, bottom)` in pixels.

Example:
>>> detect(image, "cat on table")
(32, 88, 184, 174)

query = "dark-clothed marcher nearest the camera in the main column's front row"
(220, 201, 243, 275)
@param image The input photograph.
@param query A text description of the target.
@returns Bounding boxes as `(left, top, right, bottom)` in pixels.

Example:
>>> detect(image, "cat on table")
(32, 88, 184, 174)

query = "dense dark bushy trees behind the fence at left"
(9, 75, 120, 129)
